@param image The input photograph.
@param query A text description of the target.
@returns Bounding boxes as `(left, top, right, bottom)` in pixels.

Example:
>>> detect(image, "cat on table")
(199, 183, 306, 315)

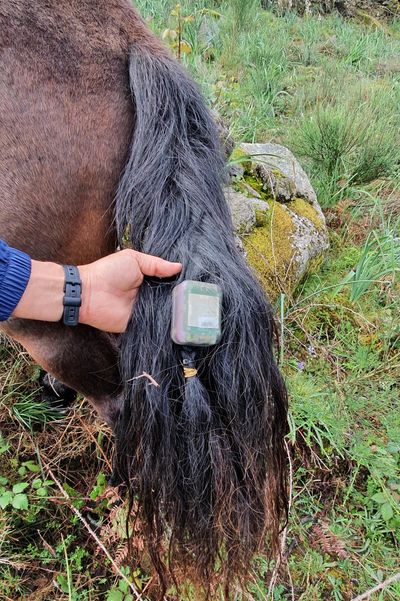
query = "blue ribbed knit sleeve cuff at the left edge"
(0, 240, 31, 321)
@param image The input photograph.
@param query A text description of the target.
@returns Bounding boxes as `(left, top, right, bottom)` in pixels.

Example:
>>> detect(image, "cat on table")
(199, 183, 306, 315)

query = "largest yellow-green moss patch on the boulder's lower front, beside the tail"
(243, 200, 296, 300)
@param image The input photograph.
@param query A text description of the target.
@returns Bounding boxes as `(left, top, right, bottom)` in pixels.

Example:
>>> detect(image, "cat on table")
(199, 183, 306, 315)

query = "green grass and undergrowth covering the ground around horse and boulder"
(0, 0, 400, 601)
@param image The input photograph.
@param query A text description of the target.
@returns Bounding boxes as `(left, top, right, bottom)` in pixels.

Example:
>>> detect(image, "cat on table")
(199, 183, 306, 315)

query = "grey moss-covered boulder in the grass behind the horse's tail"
(226, 144, 329, 300)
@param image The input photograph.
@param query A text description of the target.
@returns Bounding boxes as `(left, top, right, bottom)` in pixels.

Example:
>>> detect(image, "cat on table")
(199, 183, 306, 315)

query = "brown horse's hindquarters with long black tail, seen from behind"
(0, 0, 287, 598)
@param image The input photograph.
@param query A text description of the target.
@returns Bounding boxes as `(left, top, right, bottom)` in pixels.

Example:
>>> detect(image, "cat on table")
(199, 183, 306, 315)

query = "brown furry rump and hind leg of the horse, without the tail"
(0, 0, 148, 420)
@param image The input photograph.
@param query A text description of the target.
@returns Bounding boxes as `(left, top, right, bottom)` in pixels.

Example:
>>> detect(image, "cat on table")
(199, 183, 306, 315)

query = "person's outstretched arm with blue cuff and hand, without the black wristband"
(0, 241, 182, 333)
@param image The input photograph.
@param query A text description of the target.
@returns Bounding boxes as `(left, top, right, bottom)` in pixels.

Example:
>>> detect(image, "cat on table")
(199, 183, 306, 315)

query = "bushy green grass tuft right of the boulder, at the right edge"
(291, 96, 400, 206)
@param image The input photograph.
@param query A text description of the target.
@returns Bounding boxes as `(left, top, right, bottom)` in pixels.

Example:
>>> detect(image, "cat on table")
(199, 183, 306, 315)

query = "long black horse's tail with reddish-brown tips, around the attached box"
(115, 46, 287, 591)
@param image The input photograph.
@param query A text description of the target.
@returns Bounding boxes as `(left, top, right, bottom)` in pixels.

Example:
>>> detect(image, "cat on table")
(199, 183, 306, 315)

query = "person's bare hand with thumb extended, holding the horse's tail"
(79, 249, 182, 333)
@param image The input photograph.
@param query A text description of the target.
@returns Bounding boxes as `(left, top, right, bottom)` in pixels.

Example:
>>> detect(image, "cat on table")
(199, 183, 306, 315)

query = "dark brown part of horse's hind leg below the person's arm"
(1, 319, 122, 427)
